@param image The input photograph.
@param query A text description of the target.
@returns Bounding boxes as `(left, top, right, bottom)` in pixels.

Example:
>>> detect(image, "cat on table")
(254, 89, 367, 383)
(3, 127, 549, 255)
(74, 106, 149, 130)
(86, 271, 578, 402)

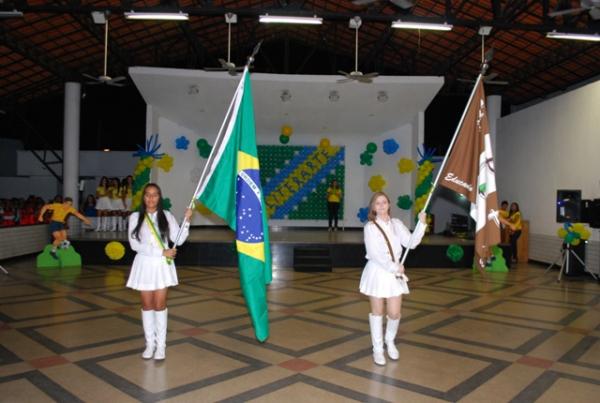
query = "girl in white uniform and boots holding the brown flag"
(360, 192, 426, 365)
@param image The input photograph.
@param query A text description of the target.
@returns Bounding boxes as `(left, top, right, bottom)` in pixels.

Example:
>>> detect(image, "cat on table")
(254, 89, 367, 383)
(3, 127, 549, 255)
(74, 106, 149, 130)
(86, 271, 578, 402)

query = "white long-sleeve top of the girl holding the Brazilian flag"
(128, 211, 190, 257)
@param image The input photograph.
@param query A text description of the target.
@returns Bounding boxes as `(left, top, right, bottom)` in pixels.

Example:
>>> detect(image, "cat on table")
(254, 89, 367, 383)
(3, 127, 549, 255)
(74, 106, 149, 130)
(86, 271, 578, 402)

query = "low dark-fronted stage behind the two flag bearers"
(70, 227, 510, 268)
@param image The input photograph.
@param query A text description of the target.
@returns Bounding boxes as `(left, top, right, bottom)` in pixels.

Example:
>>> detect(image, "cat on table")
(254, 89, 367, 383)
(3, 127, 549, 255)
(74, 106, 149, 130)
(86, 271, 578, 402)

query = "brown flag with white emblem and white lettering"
(440, 80, 500, 269)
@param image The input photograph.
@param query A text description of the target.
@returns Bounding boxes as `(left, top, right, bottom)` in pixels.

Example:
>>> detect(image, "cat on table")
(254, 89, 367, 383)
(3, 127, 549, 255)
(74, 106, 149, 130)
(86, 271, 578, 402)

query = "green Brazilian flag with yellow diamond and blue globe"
(198, 69, 272, 342)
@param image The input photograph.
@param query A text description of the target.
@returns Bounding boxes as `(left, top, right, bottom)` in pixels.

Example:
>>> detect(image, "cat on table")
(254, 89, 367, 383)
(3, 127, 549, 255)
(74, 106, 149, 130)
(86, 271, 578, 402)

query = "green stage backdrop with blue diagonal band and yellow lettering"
(258, 145, 344, 220)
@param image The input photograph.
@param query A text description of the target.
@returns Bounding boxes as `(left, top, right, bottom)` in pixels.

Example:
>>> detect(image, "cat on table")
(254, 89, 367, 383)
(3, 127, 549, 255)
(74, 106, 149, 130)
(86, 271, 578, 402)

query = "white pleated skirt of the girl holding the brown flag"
(359, 262, 410, 298)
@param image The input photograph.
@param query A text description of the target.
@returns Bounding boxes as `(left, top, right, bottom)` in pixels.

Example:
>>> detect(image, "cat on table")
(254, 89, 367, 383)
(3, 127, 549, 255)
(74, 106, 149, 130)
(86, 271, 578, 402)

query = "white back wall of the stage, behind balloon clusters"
(148, 111, 422, 227)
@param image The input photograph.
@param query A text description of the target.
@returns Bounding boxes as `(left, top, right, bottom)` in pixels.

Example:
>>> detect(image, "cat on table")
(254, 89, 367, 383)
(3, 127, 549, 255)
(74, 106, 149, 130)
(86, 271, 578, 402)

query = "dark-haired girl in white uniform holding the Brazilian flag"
(127, 183, 192, 360)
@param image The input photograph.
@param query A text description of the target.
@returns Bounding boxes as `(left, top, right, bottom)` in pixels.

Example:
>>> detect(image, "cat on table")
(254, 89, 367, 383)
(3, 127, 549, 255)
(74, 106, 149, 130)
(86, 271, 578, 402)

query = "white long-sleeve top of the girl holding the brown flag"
(364, 218, 425, 273)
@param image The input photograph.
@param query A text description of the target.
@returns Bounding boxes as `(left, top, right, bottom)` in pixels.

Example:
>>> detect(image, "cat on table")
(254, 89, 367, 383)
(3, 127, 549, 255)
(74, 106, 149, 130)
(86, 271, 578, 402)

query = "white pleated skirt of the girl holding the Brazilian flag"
(127, 253, 179, 291)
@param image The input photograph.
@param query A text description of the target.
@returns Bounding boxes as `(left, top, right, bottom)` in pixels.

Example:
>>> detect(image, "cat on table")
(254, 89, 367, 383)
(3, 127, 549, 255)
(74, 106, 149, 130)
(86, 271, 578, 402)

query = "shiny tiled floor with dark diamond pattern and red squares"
(0, 259, 600, 403)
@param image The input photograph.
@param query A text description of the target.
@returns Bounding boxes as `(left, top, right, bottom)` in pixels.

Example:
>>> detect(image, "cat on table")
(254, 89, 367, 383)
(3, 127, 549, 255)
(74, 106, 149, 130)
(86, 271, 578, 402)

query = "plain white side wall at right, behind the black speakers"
(496, 81, 600, 274)
